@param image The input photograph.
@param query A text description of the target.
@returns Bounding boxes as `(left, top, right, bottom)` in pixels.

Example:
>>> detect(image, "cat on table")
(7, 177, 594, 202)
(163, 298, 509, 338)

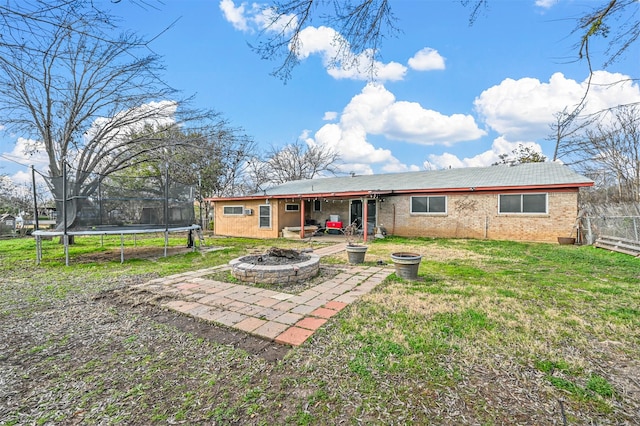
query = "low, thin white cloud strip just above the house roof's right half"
(423, 136, 542, 169)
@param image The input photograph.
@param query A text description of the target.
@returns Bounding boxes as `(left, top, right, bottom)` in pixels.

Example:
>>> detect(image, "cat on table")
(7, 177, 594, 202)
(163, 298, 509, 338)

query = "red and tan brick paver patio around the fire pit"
(136, 244, 393, 346)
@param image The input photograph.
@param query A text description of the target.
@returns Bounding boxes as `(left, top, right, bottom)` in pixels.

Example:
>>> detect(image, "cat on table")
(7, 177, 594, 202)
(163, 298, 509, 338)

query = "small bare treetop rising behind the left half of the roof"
(250, 141, 340, 190)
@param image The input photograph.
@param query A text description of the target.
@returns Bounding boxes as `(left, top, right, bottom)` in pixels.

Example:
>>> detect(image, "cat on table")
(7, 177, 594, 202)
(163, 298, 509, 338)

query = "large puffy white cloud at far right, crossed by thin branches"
(474, 71, 640, 140)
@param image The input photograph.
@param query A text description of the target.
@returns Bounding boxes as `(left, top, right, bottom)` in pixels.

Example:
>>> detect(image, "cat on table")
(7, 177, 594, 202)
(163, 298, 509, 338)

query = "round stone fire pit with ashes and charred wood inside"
(229, 247, 320, 284)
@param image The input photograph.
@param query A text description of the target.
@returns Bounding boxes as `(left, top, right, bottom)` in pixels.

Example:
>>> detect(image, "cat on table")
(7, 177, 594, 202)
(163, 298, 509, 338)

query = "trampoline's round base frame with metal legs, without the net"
(31, 225, 200, 266)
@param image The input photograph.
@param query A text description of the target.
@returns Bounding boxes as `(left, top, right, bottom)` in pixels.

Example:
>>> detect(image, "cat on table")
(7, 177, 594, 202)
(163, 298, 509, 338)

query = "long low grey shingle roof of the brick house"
(213, 162, 593, 201)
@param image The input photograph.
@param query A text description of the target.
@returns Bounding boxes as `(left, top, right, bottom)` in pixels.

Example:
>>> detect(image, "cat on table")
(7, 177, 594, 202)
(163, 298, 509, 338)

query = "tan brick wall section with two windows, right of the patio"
(378, 190, 578, 242)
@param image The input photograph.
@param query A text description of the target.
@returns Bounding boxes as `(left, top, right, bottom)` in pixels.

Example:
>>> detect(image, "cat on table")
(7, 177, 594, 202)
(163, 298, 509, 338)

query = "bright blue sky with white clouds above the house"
(0, 0, 640, 186)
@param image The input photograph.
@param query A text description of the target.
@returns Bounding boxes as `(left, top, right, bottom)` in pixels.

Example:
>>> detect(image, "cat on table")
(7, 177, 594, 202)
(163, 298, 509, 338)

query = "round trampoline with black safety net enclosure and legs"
(32, 165, 203, 265)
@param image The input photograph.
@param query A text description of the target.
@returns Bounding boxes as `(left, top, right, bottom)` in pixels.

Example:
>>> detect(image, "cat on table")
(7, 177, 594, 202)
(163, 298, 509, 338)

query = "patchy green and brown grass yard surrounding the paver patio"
(0, 237, 640, 425)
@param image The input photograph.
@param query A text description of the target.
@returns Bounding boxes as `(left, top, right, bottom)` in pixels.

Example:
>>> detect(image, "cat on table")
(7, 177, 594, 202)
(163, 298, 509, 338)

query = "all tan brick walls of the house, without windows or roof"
(214, 189, 578, 242)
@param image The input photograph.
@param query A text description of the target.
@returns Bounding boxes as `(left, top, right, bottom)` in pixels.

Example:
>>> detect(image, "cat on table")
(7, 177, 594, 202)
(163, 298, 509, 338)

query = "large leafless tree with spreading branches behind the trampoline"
(0, 0, 220, 230)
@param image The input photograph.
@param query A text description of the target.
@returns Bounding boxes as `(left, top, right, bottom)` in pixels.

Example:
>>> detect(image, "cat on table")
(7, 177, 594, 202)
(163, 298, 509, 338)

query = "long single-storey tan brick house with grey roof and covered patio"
(208, 162, 593, 242)
